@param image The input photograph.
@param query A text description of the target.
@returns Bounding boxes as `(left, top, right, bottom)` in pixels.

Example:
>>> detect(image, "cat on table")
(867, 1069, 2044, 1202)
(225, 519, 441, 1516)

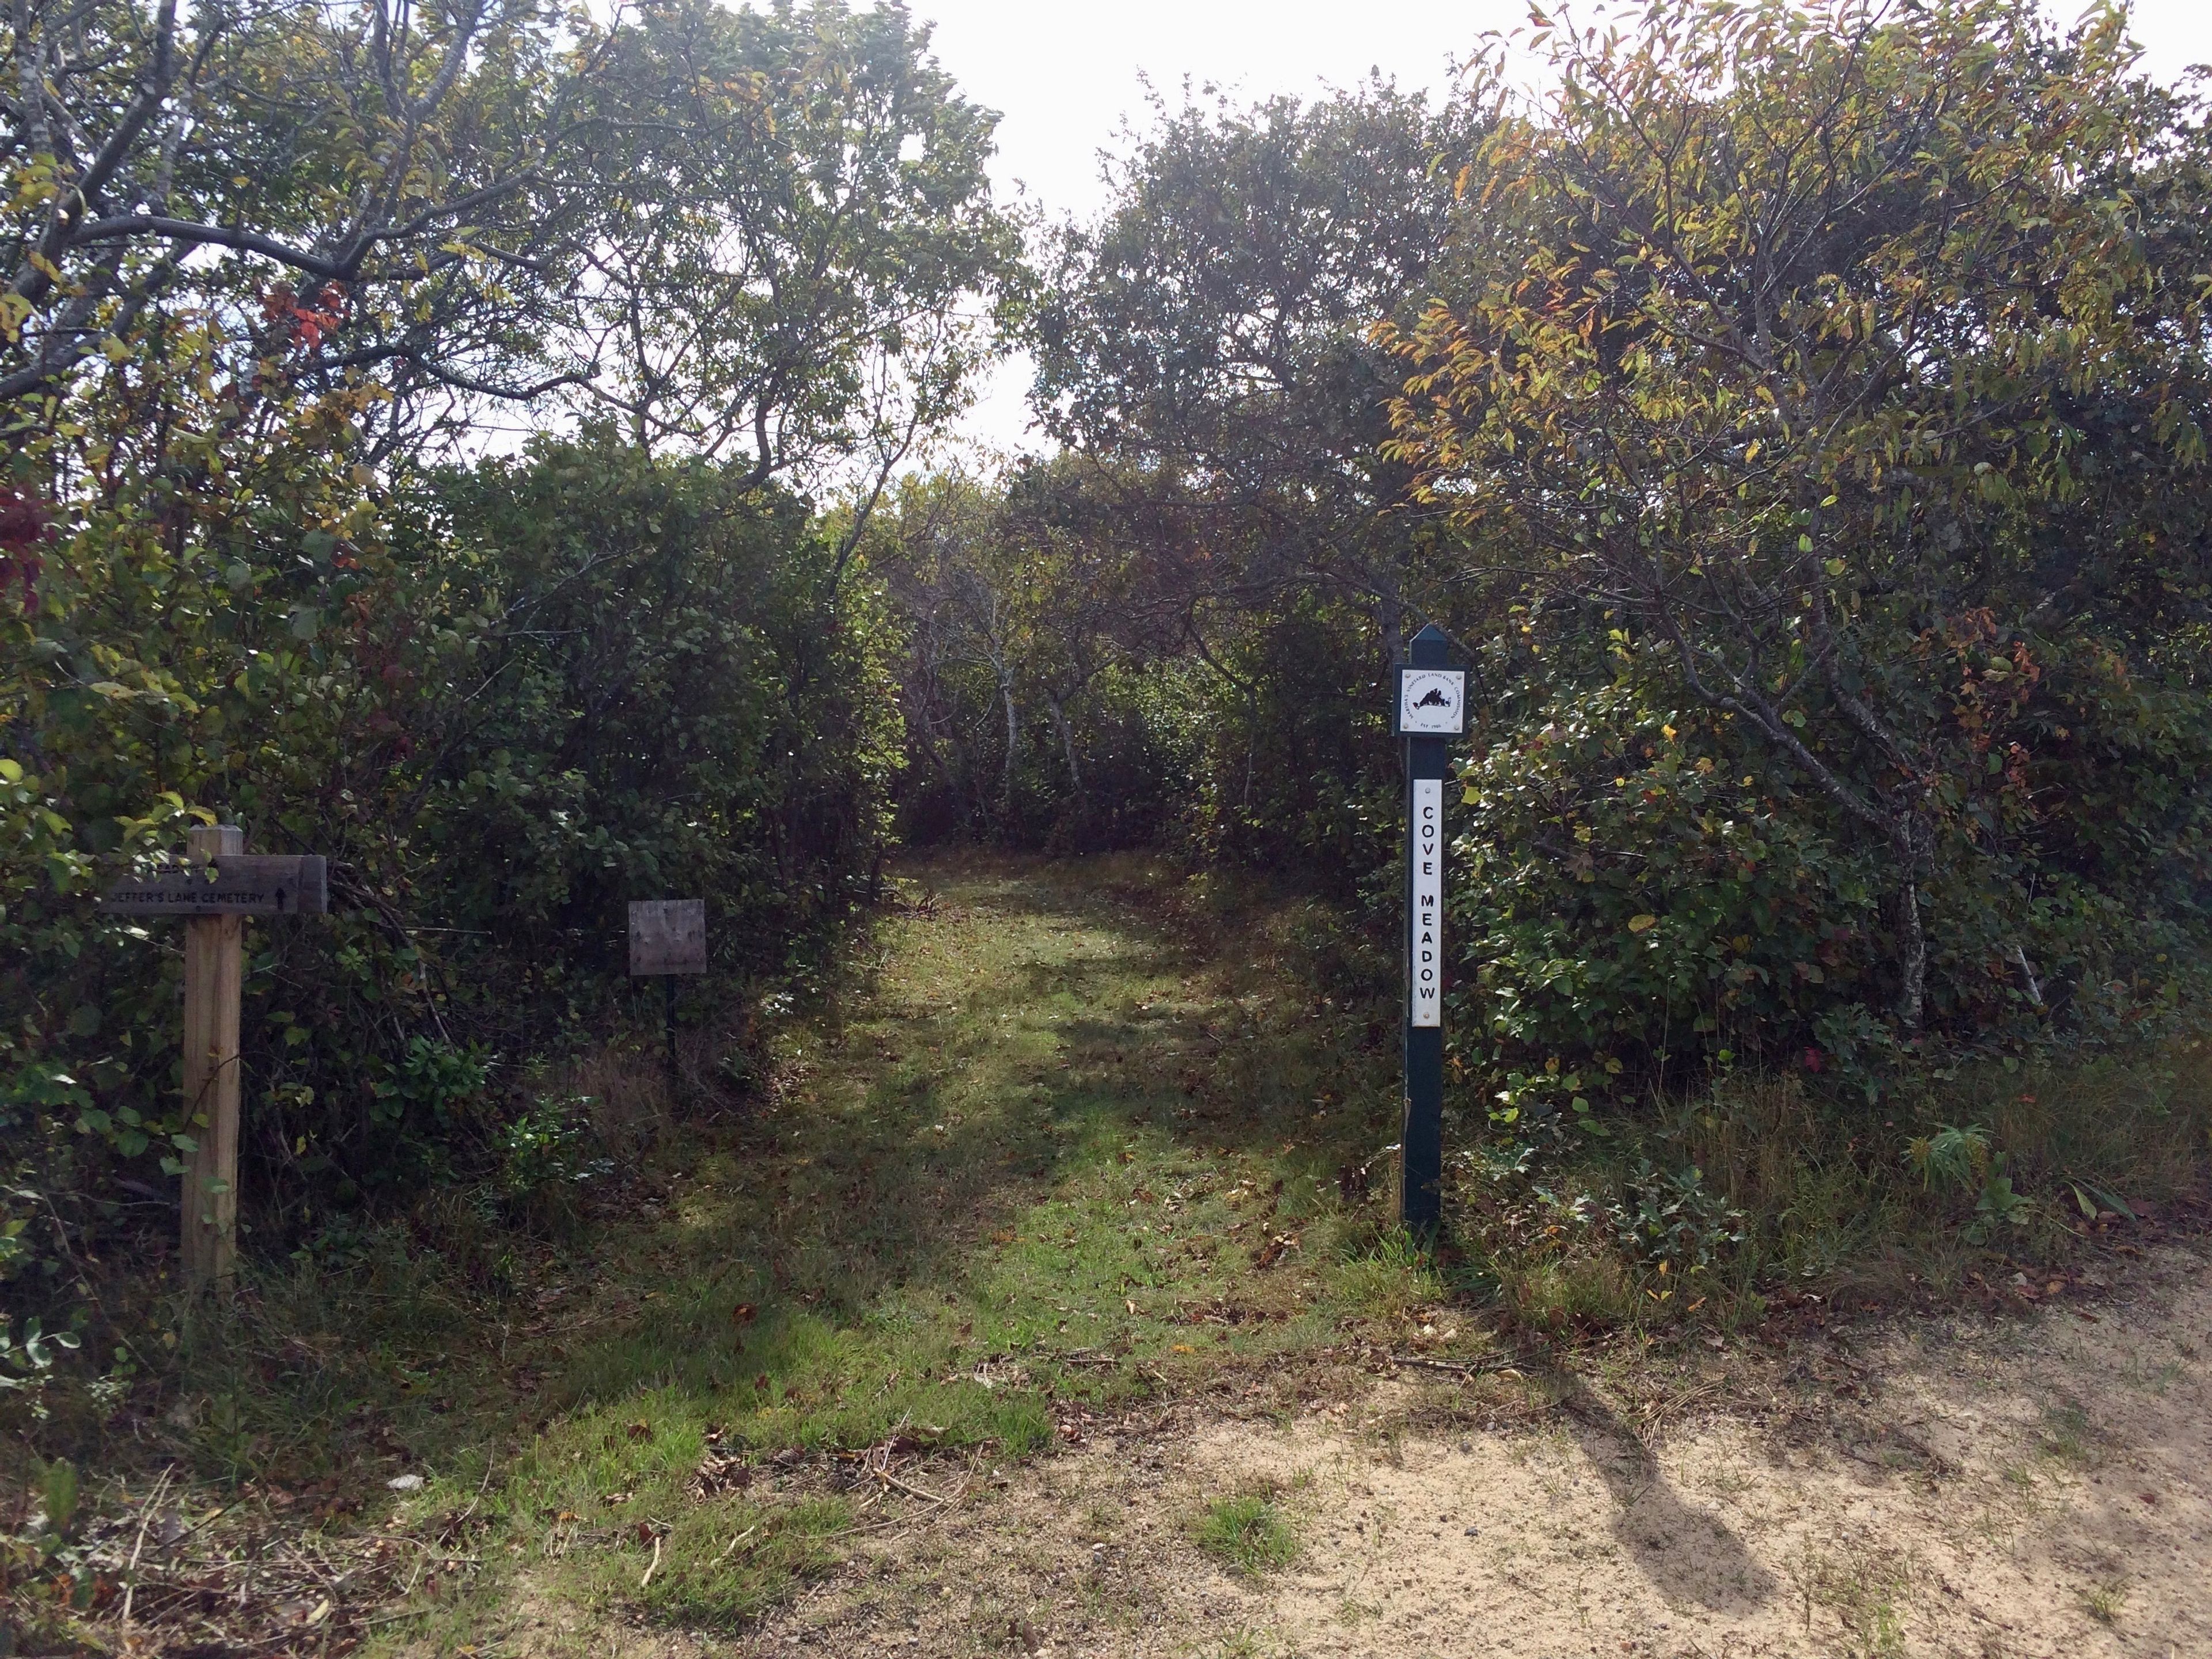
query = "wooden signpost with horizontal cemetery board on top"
(100, 825, 327, 1285)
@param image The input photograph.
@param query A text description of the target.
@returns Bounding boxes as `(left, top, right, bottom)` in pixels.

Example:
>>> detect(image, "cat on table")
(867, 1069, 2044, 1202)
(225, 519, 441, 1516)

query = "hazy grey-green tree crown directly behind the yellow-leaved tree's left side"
(1035, 82, 1486, 659)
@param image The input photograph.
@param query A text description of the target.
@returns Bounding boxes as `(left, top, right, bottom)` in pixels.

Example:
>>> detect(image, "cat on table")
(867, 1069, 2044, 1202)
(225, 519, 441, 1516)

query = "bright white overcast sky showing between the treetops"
(909, 0, 2212, 447)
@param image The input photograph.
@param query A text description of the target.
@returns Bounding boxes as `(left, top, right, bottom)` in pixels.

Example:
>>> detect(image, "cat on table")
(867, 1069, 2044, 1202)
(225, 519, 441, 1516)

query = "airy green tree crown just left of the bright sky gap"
(571, 0, 1022, 539)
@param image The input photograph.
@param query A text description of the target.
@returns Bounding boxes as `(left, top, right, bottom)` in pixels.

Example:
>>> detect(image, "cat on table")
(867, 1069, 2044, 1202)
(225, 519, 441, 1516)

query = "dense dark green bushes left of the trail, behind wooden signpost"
(0, 438, 898, 1300)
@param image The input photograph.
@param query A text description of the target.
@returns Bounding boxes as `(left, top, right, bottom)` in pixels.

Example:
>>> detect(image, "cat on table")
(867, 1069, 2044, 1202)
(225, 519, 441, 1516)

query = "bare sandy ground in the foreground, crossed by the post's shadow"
(646, 1250, 2212, 1659)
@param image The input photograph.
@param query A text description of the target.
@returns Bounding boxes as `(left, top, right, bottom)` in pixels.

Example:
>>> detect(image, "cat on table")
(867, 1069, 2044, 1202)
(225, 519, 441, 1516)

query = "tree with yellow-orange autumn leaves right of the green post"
(1380, 0, 2212, 1031)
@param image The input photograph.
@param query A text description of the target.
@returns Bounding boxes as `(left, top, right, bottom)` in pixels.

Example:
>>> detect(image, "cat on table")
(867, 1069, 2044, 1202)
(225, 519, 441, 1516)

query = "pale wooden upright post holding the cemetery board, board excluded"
(184, 825, 245, 1287)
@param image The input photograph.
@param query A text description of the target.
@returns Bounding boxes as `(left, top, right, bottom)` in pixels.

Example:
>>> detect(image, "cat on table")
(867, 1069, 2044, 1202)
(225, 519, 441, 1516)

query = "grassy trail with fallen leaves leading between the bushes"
(367, 858, 1422, 1650)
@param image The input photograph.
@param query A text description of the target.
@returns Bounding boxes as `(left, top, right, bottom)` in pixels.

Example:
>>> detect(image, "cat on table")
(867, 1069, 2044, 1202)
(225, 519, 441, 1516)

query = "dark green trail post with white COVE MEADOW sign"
(1391, 624, 1467, 1232)
